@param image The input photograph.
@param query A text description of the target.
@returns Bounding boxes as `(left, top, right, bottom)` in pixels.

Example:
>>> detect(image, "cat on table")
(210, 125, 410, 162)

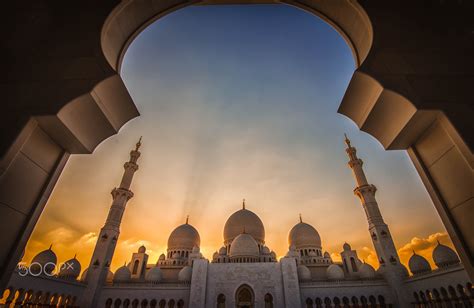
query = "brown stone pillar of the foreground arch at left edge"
(0, 120, 69, 287)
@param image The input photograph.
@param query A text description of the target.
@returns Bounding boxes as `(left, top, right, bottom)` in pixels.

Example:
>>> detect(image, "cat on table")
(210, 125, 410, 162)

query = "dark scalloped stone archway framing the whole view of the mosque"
(0, 0, 474, 288)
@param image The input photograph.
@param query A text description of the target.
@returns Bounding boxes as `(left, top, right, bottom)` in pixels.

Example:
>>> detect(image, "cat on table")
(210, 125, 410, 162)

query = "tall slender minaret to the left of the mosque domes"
(81, 137, 142, 307)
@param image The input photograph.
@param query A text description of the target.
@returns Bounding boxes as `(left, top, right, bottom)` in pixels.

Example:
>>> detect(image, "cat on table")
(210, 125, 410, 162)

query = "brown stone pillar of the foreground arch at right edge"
(408, 114, 474, 278)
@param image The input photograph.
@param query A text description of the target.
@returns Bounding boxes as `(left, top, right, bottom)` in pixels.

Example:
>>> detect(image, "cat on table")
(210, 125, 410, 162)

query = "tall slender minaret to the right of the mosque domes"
(344, 135, 408, 307)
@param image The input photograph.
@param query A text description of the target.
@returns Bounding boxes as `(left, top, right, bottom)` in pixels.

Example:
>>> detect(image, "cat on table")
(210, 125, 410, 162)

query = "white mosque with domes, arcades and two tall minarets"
(4, 137, 474, 308)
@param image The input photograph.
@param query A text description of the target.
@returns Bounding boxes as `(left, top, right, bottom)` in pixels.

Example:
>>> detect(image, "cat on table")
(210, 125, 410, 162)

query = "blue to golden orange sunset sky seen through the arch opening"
(23, 5, 452, 270)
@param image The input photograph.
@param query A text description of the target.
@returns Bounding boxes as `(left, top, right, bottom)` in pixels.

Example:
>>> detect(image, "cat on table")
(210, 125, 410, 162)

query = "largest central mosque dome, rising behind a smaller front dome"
(224, 203, 265, 245)
